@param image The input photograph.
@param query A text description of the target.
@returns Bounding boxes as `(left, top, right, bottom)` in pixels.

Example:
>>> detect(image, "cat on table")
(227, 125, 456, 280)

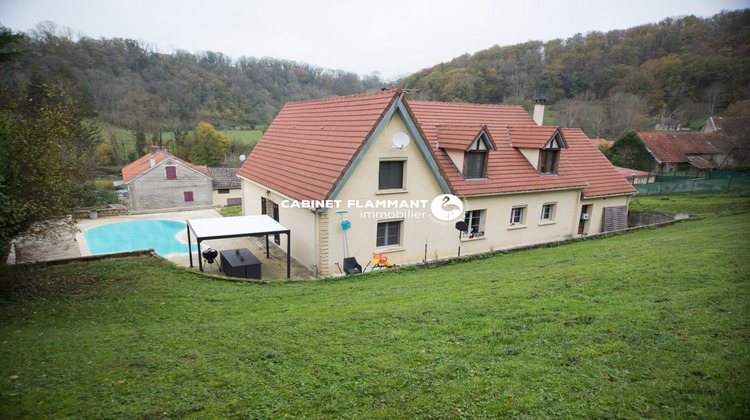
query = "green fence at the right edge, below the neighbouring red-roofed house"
(634, 171, 750, 195)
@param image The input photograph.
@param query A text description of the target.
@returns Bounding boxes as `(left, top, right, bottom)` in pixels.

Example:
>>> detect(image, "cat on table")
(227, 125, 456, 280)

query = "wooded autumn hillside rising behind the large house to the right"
(400, 9, 750, 135)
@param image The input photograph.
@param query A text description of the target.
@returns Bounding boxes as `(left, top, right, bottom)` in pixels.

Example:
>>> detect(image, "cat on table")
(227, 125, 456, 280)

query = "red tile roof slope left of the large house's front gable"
(238, 91, 400, 200)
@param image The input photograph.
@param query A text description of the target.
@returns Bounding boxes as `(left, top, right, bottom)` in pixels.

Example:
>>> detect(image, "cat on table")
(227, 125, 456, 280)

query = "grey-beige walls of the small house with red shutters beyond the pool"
(128, 158, 213, 211)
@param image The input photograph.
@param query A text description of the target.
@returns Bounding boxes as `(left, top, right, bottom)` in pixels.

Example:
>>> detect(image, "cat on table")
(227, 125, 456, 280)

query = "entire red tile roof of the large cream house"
(239, 90, 635, 200)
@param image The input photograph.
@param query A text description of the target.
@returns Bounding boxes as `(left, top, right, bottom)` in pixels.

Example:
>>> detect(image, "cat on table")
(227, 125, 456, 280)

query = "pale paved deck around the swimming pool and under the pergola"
(16, 209, 312, 279)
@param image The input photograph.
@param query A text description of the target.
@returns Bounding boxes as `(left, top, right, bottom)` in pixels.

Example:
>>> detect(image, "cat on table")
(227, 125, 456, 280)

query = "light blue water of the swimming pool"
(83, 220, 198, 255)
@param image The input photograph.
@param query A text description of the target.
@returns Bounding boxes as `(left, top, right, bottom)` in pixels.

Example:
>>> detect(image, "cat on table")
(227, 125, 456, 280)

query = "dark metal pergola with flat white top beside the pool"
(187, 214, 292, 278)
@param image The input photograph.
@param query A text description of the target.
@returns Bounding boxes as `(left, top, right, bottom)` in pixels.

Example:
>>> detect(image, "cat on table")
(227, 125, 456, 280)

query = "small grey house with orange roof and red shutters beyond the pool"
(122, 146, 212, 211)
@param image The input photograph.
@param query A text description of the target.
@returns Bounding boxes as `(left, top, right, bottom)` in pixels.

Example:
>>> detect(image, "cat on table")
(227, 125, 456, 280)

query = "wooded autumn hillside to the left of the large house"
(0, 22, 382, 133)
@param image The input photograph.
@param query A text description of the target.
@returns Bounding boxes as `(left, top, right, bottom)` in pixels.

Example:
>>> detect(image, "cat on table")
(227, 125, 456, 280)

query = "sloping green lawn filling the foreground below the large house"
(0, 199, 750, 419)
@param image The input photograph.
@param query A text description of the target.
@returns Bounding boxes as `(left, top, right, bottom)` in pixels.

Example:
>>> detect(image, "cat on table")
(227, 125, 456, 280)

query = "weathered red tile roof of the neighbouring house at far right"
(638, 131, 719, 163)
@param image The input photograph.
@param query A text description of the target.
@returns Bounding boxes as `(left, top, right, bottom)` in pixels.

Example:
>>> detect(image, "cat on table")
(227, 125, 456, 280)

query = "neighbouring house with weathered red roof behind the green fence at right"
(637, 131, 746, 173)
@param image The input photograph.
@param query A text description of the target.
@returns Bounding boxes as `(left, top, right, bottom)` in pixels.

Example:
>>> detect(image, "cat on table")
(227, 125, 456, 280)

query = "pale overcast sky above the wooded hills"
(0, 0, 750, 79)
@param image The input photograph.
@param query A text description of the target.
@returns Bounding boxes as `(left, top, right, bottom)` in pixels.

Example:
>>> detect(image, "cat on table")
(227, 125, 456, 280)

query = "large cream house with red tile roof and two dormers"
(238, 90, 635, 275)
